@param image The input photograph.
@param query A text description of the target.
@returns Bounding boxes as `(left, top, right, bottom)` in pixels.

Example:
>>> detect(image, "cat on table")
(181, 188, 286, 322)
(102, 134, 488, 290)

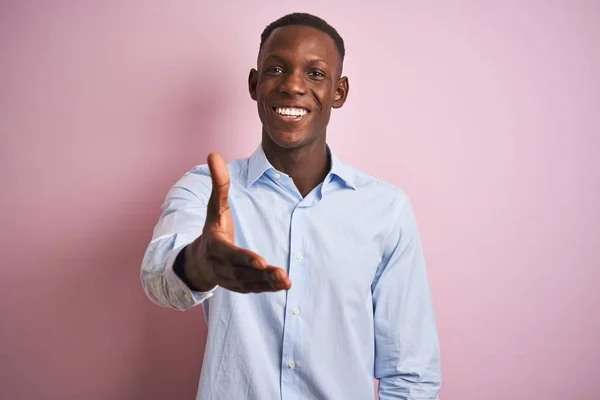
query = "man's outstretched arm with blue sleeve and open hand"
(141, 153, 291, 311)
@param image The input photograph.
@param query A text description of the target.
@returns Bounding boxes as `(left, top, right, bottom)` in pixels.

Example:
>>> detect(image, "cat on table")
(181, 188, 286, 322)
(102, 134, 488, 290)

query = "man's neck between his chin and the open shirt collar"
(262, 132, 331, 197)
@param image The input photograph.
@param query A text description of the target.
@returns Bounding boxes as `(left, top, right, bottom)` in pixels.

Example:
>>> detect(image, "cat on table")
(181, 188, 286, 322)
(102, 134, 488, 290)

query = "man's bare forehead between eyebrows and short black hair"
(260, 25, 340, 66)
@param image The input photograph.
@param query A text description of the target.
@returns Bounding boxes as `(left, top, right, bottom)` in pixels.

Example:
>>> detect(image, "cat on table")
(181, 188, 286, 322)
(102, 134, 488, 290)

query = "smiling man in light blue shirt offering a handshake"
(141, 13, 440, 400)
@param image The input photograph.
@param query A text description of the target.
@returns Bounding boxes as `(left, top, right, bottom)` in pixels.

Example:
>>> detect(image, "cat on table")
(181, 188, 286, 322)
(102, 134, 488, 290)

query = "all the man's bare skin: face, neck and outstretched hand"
(184, 26, 349, 293)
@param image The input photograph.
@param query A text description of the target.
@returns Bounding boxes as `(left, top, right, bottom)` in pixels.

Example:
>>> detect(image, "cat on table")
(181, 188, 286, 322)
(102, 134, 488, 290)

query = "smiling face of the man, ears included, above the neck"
(249, 26, 348, 149)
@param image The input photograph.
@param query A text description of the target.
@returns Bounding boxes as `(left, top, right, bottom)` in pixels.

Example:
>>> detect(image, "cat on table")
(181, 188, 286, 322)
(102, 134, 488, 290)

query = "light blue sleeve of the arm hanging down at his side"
(372, 194, 441, 400)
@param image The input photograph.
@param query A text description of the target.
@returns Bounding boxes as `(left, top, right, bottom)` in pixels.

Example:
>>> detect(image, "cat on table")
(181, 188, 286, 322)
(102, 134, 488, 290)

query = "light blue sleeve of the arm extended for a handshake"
(141, 168, 214, 311)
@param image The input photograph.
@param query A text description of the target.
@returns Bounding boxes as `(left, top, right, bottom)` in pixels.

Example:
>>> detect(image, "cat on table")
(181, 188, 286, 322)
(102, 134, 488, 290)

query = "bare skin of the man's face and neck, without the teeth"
(248, 26, 349, 196)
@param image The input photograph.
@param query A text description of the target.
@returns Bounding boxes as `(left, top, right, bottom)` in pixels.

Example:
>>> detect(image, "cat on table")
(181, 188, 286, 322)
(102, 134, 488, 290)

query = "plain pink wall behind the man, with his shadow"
(0, 0, 600, 400)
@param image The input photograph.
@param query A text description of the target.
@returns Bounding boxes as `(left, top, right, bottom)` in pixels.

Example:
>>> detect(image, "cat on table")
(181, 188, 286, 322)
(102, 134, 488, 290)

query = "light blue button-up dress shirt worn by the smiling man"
(141, 146, 441, 400)
